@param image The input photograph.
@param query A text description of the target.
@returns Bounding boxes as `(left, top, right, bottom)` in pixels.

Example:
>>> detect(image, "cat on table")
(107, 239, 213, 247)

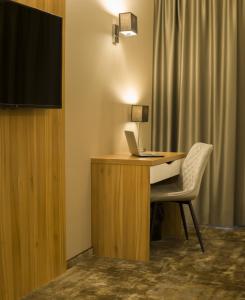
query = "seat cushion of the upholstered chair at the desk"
(151, 183, 195, 202)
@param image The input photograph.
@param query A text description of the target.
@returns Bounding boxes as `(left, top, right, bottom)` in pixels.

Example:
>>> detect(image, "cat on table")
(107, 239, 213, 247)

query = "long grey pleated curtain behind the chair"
(152, 0, 245, 226)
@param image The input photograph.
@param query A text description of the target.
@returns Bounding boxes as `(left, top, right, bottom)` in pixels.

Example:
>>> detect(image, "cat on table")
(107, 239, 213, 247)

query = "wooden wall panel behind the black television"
(0, 0, 65, 300)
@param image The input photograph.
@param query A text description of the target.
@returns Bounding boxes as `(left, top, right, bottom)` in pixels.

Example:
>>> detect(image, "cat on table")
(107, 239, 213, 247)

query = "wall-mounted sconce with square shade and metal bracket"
(112, 12, 138, 45)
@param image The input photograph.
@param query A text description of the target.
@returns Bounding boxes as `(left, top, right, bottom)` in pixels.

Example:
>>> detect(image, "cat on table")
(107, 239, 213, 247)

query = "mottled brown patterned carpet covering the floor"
(25, 227, 245, 300)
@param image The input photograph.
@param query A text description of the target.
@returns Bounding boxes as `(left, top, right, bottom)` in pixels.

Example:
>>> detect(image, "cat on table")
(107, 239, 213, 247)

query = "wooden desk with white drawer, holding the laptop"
(92, 152, 185, 261)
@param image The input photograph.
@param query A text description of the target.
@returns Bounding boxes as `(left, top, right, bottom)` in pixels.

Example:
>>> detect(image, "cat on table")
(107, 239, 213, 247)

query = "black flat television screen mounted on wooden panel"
(0, 0, 62, 108)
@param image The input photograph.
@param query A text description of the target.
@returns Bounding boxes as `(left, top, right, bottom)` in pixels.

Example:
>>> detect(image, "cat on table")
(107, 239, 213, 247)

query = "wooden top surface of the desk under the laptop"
(91, 152, 186, 166)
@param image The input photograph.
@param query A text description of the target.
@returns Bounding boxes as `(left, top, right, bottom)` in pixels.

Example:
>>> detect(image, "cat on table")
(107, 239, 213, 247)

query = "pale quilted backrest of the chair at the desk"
(179, 143, 213, 197)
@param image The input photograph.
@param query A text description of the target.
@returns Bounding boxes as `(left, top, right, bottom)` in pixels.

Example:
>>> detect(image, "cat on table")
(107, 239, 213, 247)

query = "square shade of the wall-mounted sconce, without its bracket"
(119, 12, 138, 36)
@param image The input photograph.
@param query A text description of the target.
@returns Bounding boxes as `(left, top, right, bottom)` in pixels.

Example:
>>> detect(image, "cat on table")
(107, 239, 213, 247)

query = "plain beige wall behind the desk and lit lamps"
(66, 0, 153, 258)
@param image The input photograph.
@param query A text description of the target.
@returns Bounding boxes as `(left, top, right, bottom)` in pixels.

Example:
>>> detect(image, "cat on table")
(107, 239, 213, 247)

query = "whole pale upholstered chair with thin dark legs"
(151, 143, 213, 252)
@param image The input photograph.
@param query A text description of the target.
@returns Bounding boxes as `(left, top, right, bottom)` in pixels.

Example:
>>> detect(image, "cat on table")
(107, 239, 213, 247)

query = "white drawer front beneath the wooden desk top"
(150, 159, 183, 184)
